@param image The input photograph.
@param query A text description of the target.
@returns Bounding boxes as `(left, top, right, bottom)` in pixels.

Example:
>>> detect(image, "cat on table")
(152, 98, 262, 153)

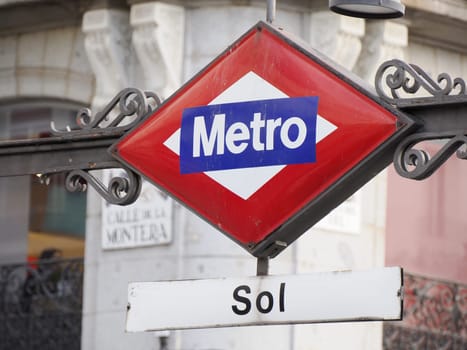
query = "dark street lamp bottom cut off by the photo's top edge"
(329, 0, 405, 19)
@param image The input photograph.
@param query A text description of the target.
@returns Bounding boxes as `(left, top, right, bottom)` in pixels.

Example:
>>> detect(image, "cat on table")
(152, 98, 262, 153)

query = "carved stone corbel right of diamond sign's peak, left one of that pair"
(310, 11, 365, 70)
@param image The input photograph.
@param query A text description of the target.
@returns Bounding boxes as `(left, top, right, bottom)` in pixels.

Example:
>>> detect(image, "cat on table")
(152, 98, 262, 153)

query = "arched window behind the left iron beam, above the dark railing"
(0, 101, 86, 259)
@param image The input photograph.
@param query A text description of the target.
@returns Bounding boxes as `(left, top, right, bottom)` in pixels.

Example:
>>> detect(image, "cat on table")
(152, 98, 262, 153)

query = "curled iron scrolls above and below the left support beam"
(51, 88, 161, 205)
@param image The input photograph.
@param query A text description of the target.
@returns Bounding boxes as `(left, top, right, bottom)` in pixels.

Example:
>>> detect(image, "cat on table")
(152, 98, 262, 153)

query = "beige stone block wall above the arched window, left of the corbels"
(0, 27, 95, 105)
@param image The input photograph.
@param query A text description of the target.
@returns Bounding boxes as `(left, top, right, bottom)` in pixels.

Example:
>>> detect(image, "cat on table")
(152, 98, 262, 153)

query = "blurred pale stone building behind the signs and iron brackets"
(0, 0, 467, 350)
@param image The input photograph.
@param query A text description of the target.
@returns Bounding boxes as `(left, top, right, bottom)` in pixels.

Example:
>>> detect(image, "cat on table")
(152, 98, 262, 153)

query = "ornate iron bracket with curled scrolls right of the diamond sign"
(375, 60, 467, 180)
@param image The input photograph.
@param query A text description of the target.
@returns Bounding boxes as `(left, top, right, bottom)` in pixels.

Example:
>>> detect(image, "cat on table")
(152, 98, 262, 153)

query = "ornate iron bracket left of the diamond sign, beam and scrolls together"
(0, 88, 160, 205)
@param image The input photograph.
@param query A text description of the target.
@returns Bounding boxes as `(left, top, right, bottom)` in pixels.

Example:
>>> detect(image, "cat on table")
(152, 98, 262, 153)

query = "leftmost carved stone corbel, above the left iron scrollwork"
(82, 9, 130, 109)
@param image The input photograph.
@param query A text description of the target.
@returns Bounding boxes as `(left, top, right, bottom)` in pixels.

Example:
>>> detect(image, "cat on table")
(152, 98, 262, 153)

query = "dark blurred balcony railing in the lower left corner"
(0, 259, 83, 350)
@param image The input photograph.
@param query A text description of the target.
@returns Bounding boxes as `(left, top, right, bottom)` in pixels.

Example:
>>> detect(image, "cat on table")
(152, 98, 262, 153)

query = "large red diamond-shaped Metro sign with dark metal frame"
(111, 22, 413, 257)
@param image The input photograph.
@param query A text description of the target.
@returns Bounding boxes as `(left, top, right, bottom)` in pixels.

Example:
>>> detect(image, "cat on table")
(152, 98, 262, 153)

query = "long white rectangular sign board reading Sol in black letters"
(126, 267, 402, 332)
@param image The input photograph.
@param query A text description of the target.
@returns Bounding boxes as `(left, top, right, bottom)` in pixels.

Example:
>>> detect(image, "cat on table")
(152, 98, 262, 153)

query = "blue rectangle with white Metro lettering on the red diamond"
(180, 96, 318, 174)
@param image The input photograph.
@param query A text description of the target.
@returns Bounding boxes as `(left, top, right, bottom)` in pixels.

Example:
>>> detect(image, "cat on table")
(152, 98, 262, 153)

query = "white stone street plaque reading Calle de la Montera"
(102, 169, 173, 249)
